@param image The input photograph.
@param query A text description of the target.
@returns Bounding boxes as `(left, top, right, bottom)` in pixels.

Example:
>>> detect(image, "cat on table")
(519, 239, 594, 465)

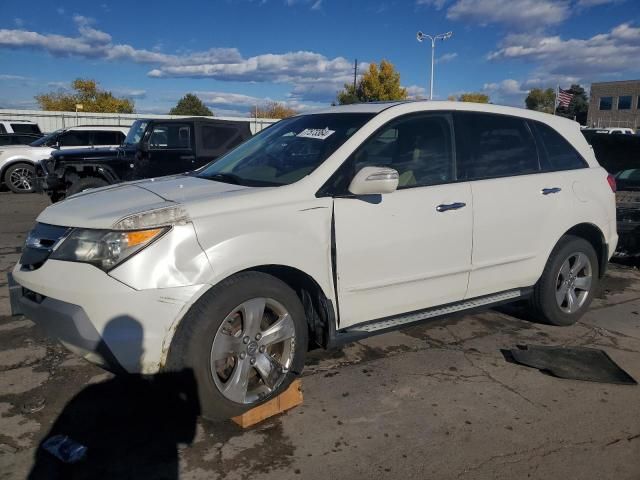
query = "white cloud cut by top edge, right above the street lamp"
(447, 0, 570, 29)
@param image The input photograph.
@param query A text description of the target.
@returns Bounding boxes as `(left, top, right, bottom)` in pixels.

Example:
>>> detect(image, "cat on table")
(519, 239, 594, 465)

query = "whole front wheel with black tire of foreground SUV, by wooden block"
(166, 272, 308, 420)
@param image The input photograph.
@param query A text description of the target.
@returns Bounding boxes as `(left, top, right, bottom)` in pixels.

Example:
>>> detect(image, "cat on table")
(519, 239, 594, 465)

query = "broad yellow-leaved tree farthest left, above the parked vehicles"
(35, 78, 135, 113)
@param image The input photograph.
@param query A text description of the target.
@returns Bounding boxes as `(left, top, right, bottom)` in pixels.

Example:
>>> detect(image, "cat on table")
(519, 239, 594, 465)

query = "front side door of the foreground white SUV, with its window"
(334, 114, 473, 328)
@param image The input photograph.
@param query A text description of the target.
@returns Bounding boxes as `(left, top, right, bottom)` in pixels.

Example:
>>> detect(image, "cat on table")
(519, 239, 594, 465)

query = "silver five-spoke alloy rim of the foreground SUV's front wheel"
(210, 298, 296, 404)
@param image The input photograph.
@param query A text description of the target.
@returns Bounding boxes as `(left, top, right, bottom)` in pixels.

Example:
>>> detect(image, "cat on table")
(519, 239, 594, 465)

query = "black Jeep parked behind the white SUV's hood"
(36, 117, 251, 202)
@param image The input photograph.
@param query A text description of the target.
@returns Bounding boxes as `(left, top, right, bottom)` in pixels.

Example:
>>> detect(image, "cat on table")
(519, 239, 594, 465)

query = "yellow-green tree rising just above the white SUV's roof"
(338, 60, 407, 105)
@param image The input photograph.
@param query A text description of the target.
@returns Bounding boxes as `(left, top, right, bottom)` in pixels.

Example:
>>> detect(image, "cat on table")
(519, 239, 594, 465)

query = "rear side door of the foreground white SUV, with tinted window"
(455, 112, 572, 298)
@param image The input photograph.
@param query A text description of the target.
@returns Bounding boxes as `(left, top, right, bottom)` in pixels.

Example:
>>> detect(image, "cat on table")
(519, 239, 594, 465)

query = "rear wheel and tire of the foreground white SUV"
(530, 235, 600, 326)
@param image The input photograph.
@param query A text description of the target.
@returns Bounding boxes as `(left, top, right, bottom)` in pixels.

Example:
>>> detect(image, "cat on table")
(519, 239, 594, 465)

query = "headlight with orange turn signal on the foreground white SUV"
(50, 227, 170, 271)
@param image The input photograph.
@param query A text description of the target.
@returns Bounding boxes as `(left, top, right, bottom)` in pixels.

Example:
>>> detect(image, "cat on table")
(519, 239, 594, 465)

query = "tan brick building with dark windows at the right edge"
(587, 80, 640, 130)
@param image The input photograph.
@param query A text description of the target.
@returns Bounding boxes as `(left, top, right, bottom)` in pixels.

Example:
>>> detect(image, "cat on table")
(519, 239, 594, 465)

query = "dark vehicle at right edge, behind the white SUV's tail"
(592, 135, 640, 257)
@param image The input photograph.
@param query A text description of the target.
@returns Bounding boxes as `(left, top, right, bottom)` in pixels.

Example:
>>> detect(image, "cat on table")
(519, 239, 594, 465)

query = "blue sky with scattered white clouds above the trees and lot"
(0, 0, 640, 116)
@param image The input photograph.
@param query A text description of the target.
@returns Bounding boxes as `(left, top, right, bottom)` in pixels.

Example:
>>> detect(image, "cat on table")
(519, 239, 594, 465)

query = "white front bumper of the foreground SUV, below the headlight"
(9, 259, 202, 374)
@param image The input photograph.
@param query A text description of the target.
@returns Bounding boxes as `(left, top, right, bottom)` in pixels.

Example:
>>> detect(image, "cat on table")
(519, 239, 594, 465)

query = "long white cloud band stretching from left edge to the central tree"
(0, 15, 358, 102)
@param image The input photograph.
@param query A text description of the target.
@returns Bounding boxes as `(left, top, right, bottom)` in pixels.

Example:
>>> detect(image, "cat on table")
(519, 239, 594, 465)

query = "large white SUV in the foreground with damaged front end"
(11, 102, 618, 417)
